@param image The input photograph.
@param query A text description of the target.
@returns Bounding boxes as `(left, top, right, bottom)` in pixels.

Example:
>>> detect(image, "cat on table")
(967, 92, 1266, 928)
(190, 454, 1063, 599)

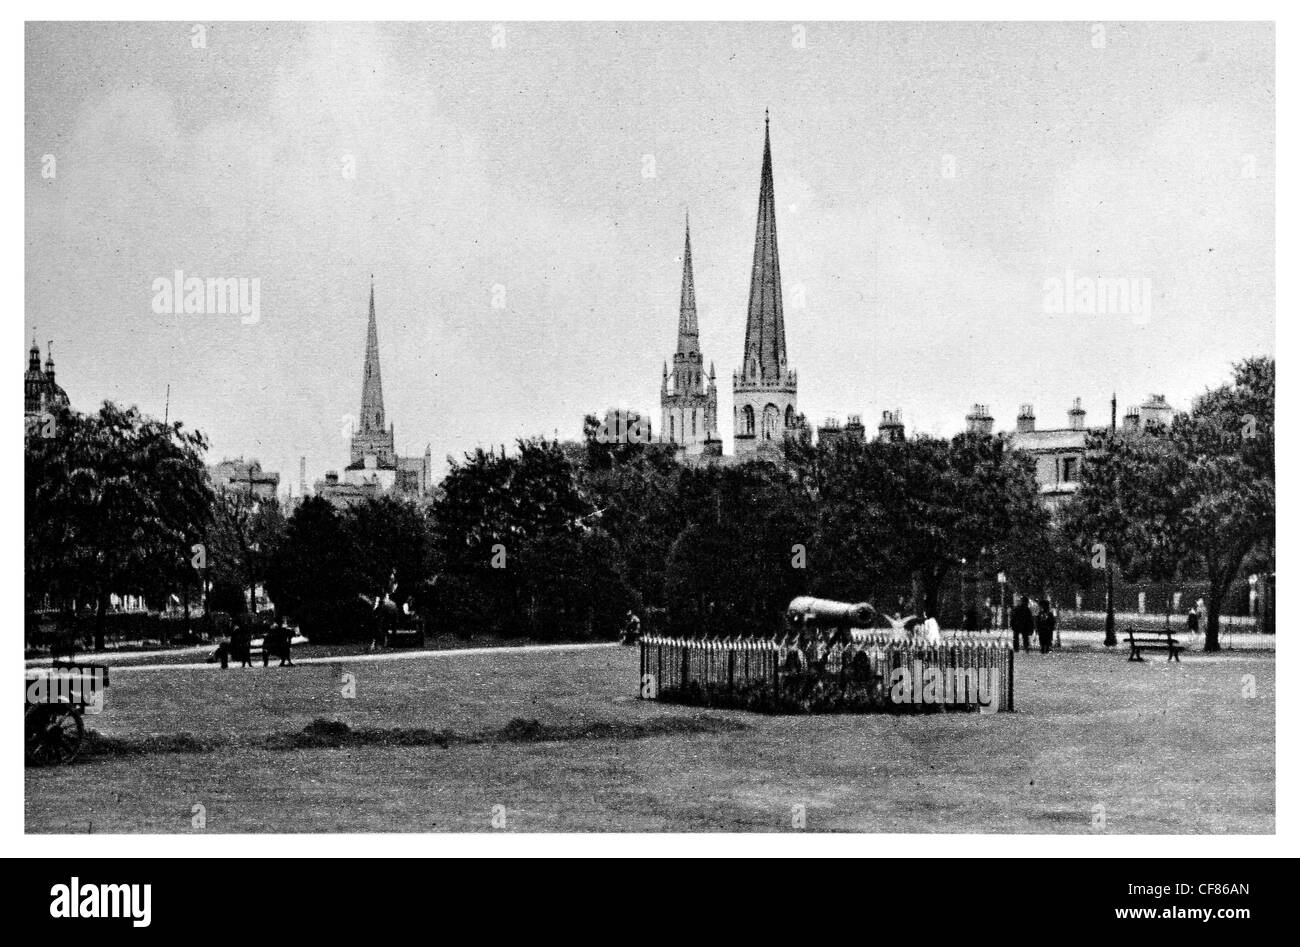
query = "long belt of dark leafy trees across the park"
(26, 359, 1274, 648)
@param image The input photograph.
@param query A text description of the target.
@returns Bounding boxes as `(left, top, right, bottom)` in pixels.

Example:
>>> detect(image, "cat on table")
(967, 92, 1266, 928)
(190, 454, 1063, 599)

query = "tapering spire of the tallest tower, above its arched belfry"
(742, 112, 785, 381)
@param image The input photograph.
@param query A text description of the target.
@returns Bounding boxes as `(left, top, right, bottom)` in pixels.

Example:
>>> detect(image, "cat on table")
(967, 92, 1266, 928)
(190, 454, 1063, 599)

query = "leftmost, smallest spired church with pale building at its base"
(316, 282, 433, 506)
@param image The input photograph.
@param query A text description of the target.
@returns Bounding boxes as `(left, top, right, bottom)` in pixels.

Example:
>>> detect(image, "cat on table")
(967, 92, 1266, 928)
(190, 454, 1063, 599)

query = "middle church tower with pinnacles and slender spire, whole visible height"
(659, 217, 720, 457)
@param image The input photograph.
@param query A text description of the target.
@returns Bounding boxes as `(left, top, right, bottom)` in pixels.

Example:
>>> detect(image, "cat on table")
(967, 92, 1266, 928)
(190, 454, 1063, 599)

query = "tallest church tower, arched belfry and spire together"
(732, 116, 798, 458)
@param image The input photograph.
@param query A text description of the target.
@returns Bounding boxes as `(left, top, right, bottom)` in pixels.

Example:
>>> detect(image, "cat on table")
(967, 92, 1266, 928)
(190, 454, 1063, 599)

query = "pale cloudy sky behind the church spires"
(25, 22, 1275, 492)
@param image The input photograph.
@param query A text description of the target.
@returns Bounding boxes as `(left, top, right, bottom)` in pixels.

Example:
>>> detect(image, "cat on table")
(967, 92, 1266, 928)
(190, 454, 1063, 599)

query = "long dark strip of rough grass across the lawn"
(81, 717, 746, 760)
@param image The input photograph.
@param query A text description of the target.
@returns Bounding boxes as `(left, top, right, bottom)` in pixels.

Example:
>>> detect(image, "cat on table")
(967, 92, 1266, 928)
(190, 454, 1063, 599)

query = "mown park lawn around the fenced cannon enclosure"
(25, 647, 1275, 834)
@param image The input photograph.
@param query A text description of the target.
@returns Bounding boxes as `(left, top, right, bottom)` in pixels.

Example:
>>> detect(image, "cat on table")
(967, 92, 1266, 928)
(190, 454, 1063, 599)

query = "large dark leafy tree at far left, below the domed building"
(25, 402, 212, 649)
